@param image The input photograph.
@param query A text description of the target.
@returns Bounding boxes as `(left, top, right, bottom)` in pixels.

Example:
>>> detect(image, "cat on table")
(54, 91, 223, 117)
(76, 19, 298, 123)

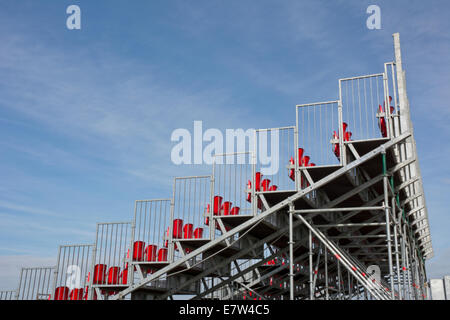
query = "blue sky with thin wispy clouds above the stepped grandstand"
(0, 0, 450, 289)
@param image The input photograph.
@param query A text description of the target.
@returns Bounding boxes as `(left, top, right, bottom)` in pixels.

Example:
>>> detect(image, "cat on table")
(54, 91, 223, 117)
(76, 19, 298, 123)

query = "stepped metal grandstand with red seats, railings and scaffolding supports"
(0, 34, 433, 300)
